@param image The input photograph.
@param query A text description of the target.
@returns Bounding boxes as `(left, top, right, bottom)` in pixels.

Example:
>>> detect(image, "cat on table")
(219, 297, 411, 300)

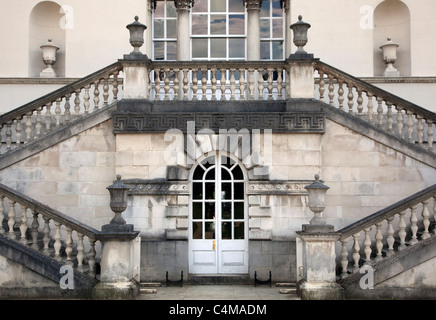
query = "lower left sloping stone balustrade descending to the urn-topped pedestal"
(0, 184, 102, 277)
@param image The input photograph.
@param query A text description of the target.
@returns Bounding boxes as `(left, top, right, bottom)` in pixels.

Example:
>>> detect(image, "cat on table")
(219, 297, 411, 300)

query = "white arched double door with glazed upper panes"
(189, 151, 248, 274)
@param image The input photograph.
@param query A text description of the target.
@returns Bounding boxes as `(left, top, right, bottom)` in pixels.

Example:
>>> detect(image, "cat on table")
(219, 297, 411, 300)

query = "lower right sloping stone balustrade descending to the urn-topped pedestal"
(338, 184, 436, 279)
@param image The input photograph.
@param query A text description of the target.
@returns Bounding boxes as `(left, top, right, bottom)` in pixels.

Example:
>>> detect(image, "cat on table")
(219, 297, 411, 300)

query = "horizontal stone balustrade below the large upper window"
(149, 61, 289, 101)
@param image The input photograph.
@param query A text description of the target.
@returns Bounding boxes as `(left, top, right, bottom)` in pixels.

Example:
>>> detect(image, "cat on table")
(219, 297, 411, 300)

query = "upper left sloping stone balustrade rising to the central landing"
(0, 62, 122, 154)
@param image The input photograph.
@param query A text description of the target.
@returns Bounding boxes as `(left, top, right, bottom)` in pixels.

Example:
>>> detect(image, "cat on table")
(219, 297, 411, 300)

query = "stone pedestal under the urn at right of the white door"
(297, 225, 343, 300)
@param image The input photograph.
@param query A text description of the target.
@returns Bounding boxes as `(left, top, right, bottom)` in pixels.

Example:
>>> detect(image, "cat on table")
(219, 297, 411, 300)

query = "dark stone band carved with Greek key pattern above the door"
(112, 112, 325, 133)
